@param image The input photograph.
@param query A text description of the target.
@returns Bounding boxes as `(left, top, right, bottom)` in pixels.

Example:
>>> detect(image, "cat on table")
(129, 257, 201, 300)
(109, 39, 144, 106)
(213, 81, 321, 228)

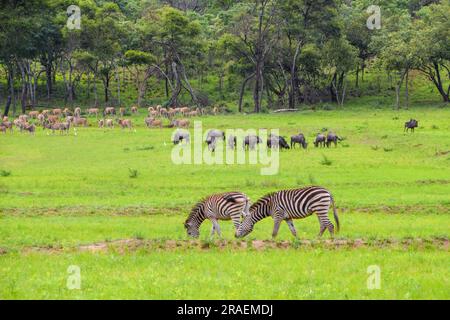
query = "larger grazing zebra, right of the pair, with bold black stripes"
(236, 187, 339, 238)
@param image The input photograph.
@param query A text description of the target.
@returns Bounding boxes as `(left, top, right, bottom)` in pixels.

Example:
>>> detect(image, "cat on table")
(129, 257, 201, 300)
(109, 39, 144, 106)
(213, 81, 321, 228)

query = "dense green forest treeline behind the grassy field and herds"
(0, 0, 450, 114)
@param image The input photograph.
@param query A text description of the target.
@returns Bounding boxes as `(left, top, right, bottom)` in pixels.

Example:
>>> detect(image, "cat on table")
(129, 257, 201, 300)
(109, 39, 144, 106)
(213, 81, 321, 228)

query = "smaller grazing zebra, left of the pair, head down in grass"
(184, 192, 250, 238)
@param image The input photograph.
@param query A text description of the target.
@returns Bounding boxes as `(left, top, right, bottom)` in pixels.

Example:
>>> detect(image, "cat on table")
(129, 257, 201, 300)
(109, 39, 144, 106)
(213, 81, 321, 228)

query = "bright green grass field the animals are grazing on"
(0, 106, 450, 299)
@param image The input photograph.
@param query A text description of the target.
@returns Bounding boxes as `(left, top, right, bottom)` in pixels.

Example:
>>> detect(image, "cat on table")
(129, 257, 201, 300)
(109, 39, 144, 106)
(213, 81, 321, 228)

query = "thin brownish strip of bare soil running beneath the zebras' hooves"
(16, 237, 449, 254)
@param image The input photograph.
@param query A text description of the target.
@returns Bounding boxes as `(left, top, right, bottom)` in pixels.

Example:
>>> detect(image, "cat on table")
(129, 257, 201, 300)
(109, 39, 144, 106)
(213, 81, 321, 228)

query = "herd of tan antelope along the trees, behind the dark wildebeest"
(0, 105, 219, 135)
